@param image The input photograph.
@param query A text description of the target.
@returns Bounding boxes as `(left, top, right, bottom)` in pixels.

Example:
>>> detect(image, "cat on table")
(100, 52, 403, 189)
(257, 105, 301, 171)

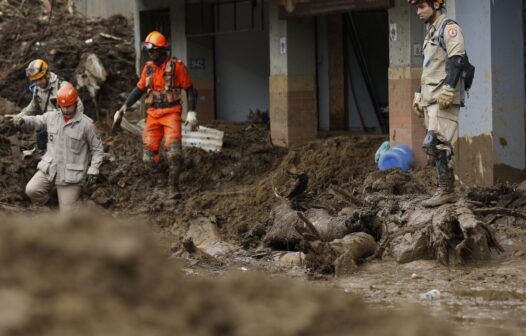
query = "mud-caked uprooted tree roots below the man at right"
(266, 192, 503, 275)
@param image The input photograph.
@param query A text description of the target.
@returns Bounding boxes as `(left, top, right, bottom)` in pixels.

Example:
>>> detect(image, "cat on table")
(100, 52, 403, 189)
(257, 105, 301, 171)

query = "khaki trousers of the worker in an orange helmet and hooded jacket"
(26, 170, 82, 212)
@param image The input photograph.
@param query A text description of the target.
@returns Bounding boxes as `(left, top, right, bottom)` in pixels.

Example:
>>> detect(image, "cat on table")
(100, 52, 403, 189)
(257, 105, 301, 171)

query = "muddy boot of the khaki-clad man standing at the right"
(422, 151, 458, 208)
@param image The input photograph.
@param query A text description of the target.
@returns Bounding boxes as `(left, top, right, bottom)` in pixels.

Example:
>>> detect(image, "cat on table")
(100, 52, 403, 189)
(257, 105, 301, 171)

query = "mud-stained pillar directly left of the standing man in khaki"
(388, 0, 427, 167)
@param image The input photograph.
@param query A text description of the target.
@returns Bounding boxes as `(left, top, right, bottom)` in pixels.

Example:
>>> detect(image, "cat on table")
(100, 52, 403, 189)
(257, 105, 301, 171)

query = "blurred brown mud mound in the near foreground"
(0, 213, 513, 336)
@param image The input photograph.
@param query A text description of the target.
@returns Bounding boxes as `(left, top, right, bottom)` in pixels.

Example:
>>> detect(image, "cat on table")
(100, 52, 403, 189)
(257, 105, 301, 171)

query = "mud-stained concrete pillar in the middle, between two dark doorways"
(269, 1, 317, 146)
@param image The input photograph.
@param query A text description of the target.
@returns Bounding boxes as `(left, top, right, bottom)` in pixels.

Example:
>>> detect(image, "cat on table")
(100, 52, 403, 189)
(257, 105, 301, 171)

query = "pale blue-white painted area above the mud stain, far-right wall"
(456, 0, 525, 169)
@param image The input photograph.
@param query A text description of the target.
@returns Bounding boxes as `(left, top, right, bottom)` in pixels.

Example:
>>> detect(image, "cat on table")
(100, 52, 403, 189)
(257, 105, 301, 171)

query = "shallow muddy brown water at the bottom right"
(334, 258, 526, 334)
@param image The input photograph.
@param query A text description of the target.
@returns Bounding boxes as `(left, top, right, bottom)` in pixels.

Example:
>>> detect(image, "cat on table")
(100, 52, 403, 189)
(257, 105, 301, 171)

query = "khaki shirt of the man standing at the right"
(421, 14, 466, 106)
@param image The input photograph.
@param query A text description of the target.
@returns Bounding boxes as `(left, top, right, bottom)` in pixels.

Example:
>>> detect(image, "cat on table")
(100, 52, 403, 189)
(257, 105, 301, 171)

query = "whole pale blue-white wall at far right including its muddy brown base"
(455, 0, 525, 186)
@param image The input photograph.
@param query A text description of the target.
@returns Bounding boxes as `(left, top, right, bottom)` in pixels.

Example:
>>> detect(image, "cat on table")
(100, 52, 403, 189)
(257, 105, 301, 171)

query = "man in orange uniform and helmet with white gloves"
(115, 31, 198, 198)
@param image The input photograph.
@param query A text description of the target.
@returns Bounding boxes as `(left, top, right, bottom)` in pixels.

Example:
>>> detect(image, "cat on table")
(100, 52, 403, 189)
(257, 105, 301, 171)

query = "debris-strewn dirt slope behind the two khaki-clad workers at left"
(0, 0, 137, 119)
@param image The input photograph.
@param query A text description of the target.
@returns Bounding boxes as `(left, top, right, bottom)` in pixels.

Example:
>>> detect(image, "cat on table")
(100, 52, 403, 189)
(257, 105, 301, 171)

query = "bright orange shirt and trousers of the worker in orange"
(137, 57, 192, 164)
